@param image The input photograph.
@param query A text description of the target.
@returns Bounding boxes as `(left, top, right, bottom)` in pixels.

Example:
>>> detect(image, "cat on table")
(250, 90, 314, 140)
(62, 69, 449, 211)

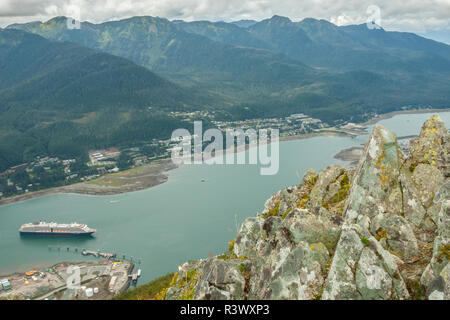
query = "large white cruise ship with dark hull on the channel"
(19, 221, 97, 237)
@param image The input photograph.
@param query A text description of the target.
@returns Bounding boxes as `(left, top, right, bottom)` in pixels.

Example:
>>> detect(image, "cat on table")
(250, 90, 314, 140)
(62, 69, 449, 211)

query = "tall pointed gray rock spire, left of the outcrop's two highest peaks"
(322, 125, 410, 299)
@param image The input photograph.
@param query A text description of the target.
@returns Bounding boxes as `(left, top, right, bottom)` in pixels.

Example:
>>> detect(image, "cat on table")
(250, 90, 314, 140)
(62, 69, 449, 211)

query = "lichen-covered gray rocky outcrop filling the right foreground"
(161, 116, 450, 299)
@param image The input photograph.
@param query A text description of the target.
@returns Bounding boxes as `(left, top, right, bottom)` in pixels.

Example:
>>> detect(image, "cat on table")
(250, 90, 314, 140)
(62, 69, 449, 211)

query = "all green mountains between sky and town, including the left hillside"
(0, 16, 450, 171)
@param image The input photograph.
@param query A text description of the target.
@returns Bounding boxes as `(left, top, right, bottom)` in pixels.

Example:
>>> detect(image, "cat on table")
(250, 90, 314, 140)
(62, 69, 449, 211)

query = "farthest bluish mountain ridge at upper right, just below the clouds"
(176, 16, 450, 71)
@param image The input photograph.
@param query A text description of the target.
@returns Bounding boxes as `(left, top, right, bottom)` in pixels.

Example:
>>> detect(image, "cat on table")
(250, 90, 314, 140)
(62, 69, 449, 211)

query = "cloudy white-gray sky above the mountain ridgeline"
(0, 0, 450, 42)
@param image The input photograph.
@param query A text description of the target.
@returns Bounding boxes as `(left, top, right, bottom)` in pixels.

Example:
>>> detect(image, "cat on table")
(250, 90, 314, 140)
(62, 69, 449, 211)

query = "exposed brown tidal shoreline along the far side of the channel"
(0, 108, 450, 207)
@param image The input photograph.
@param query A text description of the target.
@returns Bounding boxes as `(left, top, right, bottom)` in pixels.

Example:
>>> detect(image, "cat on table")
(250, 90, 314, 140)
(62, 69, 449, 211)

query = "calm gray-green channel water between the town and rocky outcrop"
(0, 111, 450, 283)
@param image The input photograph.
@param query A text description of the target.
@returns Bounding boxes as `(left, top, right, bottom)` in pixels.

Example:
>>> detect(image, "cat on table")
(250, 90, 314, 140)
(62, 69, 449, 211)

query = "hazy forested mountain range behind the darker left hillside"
(9, 16, 450, 121)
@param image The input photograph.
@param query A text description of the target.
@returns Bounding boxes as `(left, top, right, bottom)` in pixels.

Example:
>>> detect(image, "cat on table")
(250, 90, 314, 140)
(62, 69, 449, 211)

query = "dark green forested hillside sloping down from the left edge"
(0, 30, 196, 171)
